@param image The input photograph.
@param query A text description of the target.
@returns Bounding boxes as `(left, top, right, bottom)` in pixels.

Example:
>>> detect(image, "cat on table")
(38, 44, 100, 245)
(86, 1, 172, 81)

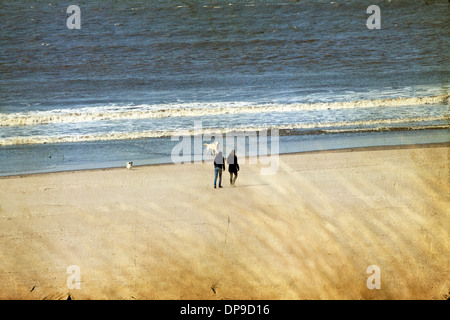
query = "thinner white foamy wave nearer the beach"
(0, 116, 450, 146)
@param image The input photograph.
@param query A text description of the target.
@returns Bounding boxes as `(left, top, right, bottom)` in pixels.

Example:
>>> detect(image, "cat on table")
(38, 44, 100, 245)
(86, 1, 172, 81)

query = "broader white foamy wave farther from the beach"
(0, 95, 449, 127)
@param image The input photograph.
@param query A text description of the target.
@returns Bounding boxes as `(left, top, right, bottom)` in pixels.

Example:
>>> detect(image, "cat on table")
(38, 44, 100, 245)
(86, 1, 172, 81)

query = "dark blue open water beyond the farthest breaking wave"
(0, 0, 450, 112)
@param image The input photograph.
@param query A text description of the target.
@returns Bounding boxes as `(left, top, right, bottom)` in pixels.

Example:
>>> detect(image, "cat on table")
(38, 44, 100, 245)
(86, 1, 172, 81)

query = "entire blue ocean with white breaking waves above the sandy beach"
(0, 0, 450, 176)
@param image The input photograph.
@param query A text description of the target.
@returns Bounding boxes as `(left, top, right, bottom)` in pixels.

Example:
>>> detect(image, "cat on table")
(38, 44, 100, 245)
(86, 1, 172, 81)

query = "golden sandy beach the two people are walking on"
(0, 144, 450, 300)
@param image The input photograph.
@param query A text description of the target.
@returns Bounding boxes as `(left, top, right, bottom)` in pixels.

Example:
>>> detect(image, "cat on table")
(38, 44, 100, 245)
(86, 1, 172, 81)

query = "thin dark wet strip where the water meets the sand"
(0, 142, 450, 180)
